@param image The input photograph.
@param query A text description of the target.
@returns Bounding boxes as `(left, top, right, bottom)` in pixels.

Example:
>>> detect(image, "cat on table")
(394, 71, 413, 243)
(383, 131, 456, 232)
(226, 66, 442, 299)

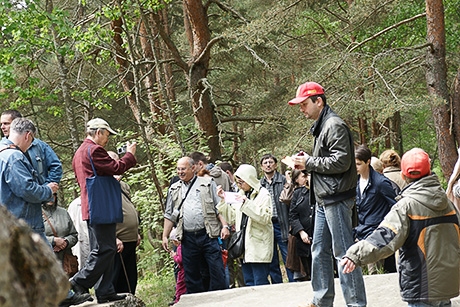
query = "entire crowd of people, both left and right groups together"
(0, 82, 460, 307)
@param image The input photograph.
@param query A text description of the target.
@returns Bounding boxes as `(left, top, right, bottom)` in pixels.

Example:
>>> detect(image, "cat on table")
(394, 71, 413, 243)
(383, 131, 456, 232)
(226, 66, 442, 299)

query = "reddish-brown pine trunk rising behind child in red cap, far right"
(425, 0, 457, 178)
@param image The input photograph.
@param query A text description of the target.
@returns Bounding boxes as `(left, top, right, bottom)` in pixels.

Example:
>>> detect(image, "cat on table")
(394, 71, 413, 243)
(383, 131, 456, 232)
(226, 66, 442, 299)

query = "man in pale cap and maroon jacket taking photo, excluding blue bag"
(70, 118, 136, 304)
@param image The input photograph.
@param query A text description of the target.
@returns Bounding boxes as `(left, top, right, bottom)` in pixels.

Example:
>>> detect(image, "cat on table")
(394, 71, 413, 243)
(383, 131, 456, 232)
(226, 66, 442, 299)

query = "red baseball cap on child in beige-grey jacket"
(401, 148, 431, 178)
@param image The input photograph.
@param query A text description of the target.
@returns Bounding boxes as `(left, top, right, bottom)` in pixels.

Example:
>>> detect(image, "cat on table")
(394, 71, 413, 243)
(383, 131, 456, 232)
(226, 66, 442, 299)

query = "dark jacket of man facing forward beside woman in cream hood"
(260, 171, 289, 242)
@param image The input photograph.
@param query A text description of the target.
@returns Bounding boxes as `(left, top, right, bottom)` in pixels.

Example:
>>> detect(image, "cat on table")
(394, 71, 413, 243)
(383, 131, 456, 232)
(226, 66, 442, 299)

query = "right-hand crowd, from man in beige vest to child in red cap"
(163, 82, 460, 307)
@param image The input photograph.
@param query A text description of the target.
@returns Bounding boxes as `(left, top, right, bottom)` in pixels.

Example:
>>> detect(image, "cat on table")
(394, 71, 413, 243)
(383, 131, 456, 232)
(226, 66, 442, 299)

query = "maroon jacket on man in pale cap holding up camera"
(72, 139, 136, 221)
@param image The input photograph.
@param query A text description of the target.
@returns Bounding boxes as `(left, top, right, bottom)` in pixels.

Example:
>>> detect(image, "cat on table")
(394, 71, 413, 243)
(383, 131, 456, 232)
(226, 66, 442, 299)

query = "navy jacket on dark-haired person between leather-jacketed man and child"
(353, 166, 396, 240)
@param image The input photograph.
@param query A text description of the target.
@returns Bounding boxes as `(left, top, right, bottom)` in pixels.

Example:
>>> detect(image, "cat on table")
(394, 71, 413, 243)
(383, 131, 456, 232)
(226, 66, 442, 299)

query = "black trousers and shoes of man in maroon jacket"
(72, 222, 117, 297)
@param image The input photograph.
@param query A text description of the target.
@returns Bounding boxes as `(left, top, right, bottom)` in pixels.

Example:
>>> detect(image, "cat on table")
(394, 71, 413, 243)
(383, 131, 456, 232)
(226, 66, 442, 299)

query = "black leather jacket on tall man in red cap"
(305, 105, 358, 205)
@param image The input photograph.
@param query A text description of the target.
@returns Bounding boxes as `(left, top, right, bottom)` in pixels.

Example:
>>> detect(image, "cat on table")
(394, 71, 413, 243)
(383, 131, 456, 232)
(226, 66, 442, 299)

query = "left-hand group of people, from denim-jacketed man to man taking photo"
(0, 110, 140, 307)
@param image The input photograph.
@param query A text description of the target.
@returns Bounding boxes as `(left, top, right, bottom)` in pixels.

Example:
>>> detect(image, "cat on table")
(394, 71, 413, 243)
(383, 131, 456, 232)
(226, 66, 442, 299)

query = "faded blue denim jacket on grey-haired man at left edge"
(0, 139, 53, 232)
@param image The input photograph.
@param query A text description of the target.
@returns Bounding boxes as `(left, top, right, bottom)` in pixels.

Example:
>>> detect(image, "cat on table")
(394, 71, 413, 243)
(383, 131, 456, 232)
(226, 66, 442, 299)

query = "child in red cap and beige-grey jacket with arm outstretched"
(341, 148, 460, 307)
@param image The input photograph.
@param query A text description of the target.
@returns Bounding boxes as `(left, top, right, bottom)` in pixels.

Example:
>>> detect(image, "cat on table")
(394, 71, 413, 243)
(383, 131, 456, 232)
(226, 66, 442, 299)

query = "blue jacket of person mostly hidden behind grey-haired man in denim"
(27, 139, 62, 184)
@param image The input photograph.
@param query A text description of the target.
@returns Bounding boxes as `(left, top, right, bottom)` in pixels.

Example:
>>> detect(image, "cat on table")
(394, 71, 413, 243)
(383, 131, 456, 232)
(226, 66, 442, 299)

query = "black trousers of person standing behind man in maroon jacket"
(112, 241, 137, 295)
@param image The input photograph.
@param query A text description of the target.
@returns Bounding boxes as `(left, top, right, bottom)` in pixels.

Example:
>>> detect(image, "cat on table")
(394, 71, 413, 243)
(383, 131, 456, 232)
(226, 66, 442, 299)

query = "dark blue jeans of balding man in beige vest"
(181, 229, 227, 293)
